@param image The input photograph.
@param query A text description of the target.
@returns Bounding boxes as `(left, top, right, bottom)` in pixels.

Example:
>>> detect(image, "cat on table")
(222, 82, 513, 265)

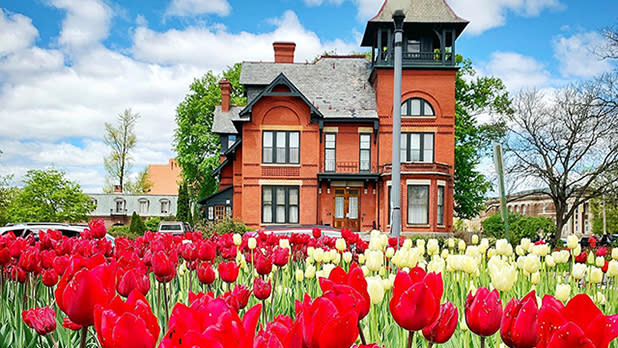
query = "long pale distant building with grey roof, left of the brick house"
(88, 192, 178, 228)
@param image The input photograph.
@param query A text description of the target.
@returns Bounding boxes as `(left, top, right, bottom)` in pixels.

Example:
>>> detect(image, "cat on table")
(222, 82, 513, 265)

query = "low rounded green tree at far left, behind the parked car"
(8, 169, 94, 222)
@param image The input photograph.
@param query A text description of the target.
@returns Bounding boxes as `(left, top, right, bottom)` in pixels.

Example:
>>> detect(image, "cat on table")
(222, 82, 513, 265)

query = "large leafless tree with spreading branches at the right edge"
(507, 81, 618, 244)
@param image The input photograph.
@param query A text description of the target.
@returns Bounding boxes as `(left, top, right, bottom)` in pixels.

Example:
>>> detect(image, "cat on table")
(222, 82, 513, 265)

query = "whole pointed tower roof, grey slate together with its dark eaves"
(361, 0, 469, 46)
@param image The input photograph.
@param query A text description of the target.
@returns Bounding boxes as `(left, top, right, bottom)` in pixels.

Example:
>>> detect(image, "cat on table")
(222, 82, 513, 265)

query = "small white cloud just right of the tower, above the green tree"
(478, 52, 551, 92)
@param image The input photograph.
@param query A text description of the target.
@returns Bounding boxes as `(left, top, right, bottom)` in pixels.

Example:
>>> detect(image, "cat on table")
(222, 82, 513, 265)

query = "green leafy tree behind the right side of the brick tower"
(454, 55, 512, 219)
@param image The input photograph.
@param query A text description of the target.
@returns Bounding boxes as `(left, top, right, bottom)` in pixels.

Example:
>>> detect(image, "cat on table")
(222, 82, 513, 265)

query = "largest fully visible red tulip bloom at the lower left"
(55, 254, 116, 326)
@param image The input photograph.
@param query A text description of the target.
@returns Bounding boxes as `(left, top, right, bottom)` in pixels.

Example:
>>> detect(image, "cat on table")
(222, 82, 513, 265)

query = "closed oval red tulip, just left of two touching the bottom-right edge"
(465, 288, 502, 337)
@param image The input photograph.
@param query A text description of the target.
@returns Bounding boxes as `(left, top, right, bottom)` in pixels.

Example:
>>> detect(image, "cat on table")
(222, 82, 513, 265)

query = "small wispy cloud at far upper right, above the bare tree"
(553, 32, 614, 78)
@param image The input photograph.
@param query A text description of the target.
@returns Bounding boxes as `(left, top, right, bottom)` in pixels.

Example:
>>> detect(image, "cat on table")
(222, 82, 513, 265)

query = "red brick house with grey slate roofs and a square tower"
(201, 0, 468, 232)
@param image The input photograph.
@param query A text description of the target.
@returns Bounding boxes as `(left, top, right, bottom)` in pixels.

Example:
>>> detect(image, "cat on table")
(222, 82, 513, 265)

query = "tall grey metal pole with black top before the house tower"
(391, 10, 405, 237)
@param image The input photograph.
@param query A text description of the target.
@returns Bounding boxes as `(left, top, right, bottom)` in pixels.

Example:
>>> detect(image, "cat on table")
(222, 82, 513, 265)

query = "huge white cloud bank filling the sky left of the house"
(0, 0, 357, 192)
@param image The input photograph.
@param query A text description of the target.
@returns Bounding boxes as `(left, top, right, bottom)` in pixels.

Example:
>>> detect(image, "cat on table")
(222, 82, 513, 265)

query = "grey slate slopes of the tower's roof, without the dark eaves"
(369, 0, 468, 24)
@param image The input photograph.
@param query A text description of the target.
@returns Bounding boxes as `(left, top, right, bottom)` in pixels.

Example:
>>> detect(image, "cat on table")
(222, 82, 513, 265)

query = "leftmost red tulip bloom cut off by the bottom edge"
(94, 290, 160, 348)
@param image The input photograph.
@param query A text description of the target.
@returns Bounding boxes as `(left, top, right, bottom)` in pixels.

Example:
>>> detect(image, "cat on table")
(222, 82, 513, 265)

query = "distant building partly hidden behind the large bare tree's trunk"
(481, 190, 592, 236)
